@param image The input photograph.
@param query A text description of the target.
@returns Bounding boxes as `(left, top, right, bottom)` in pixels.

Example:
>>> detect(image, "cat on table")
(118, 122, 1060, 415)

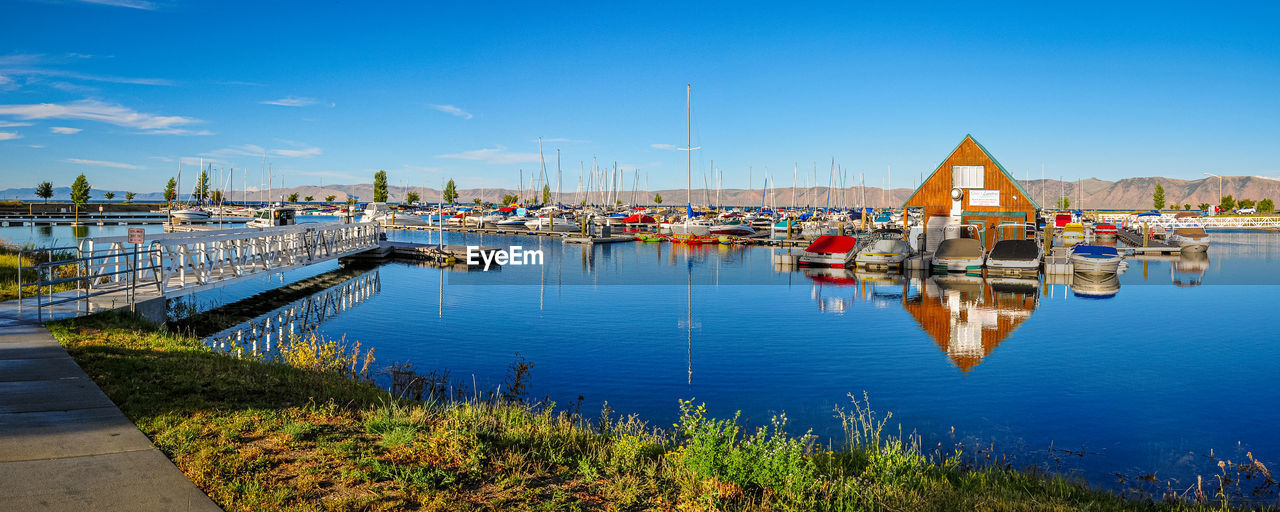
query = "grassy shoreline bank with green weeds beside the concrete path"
(49, 314, 1270, 511)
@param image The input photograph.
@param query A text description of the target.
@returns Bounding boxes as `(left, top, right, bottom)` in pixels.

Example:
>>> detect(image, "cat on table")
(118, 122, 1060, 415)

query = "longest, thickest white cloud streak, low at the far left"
(0, 100, 200, 134)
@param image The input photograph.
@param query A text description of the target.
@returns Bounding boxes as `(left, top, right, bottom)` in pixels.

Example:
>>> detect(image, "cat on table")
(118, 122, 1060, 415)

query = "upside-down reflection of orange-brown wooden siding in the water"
(902, 283, 1037, 372)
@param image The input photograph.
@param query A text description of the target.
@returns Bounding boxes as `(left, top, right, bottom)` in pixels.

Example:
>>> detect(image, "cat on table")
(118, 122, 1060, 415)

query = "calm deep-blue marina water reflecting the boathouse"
(0, 222, 1280, 484)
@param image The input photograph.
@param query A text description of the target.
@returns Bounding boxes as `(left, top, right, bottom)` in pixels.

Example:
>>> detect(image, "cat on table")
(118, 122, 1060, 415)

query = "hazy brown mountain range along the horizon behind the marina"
(0, 177, 1280, 209)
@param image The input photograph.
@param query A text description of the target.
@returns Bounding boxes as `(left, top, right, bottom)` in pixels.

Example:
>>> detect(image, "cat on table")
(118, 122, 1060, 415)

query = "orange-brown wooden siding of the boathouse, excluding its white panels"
(904, 136, 1036, 250)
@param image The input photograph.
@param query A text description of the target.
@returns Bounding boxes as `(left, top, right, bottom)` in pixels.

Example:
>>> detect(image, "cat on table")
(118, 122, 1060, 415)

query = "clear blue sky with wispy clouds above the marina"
(0, 0, 1280, 192)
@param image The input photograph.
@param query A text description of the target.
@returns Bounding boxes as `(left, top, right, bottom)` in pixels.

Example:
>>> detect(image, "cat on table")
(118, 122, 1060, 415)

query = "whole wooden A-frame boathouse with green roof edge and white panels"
(902, 134, 1039, 251)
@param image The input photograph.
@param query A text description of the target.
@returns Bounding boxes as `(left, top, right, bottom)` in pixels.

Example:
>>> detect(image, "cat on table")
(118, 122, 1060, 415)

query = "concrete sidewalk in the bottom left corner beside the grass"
(0, 315, 220, 512)
